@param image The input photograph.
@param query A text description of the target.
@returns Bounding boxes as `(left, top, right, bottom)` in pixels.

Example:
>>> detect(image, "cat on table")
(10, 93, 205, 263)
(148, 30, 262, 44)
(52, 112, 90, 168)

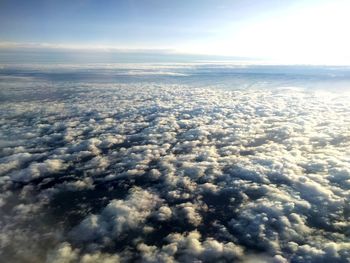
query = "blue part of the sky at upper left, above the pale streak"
(0, 0, 288, 44)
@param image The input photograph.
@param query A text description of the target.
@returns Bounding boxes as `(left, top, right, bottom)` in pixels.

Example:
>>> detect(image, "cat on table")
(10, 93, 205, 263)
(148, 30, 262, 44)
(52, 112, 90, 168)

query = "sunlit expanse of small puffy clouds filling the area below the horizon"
(0, 70, 350, 263)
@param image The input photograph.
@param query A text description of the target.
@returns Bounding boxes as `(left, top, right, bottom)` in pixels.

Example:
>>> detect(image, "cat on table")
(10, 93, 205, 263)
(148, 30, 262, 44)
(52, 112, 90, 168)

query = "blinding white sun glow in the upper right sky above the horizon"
(176, 1, 350, 64)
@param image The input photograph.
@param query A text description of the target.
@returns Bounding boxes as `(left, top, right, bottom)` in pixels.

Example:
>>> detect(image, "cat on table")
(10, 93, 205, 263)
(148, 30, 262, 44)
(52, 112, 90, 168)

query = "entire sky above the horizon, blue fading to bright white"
(0, 0, 350, 64)
